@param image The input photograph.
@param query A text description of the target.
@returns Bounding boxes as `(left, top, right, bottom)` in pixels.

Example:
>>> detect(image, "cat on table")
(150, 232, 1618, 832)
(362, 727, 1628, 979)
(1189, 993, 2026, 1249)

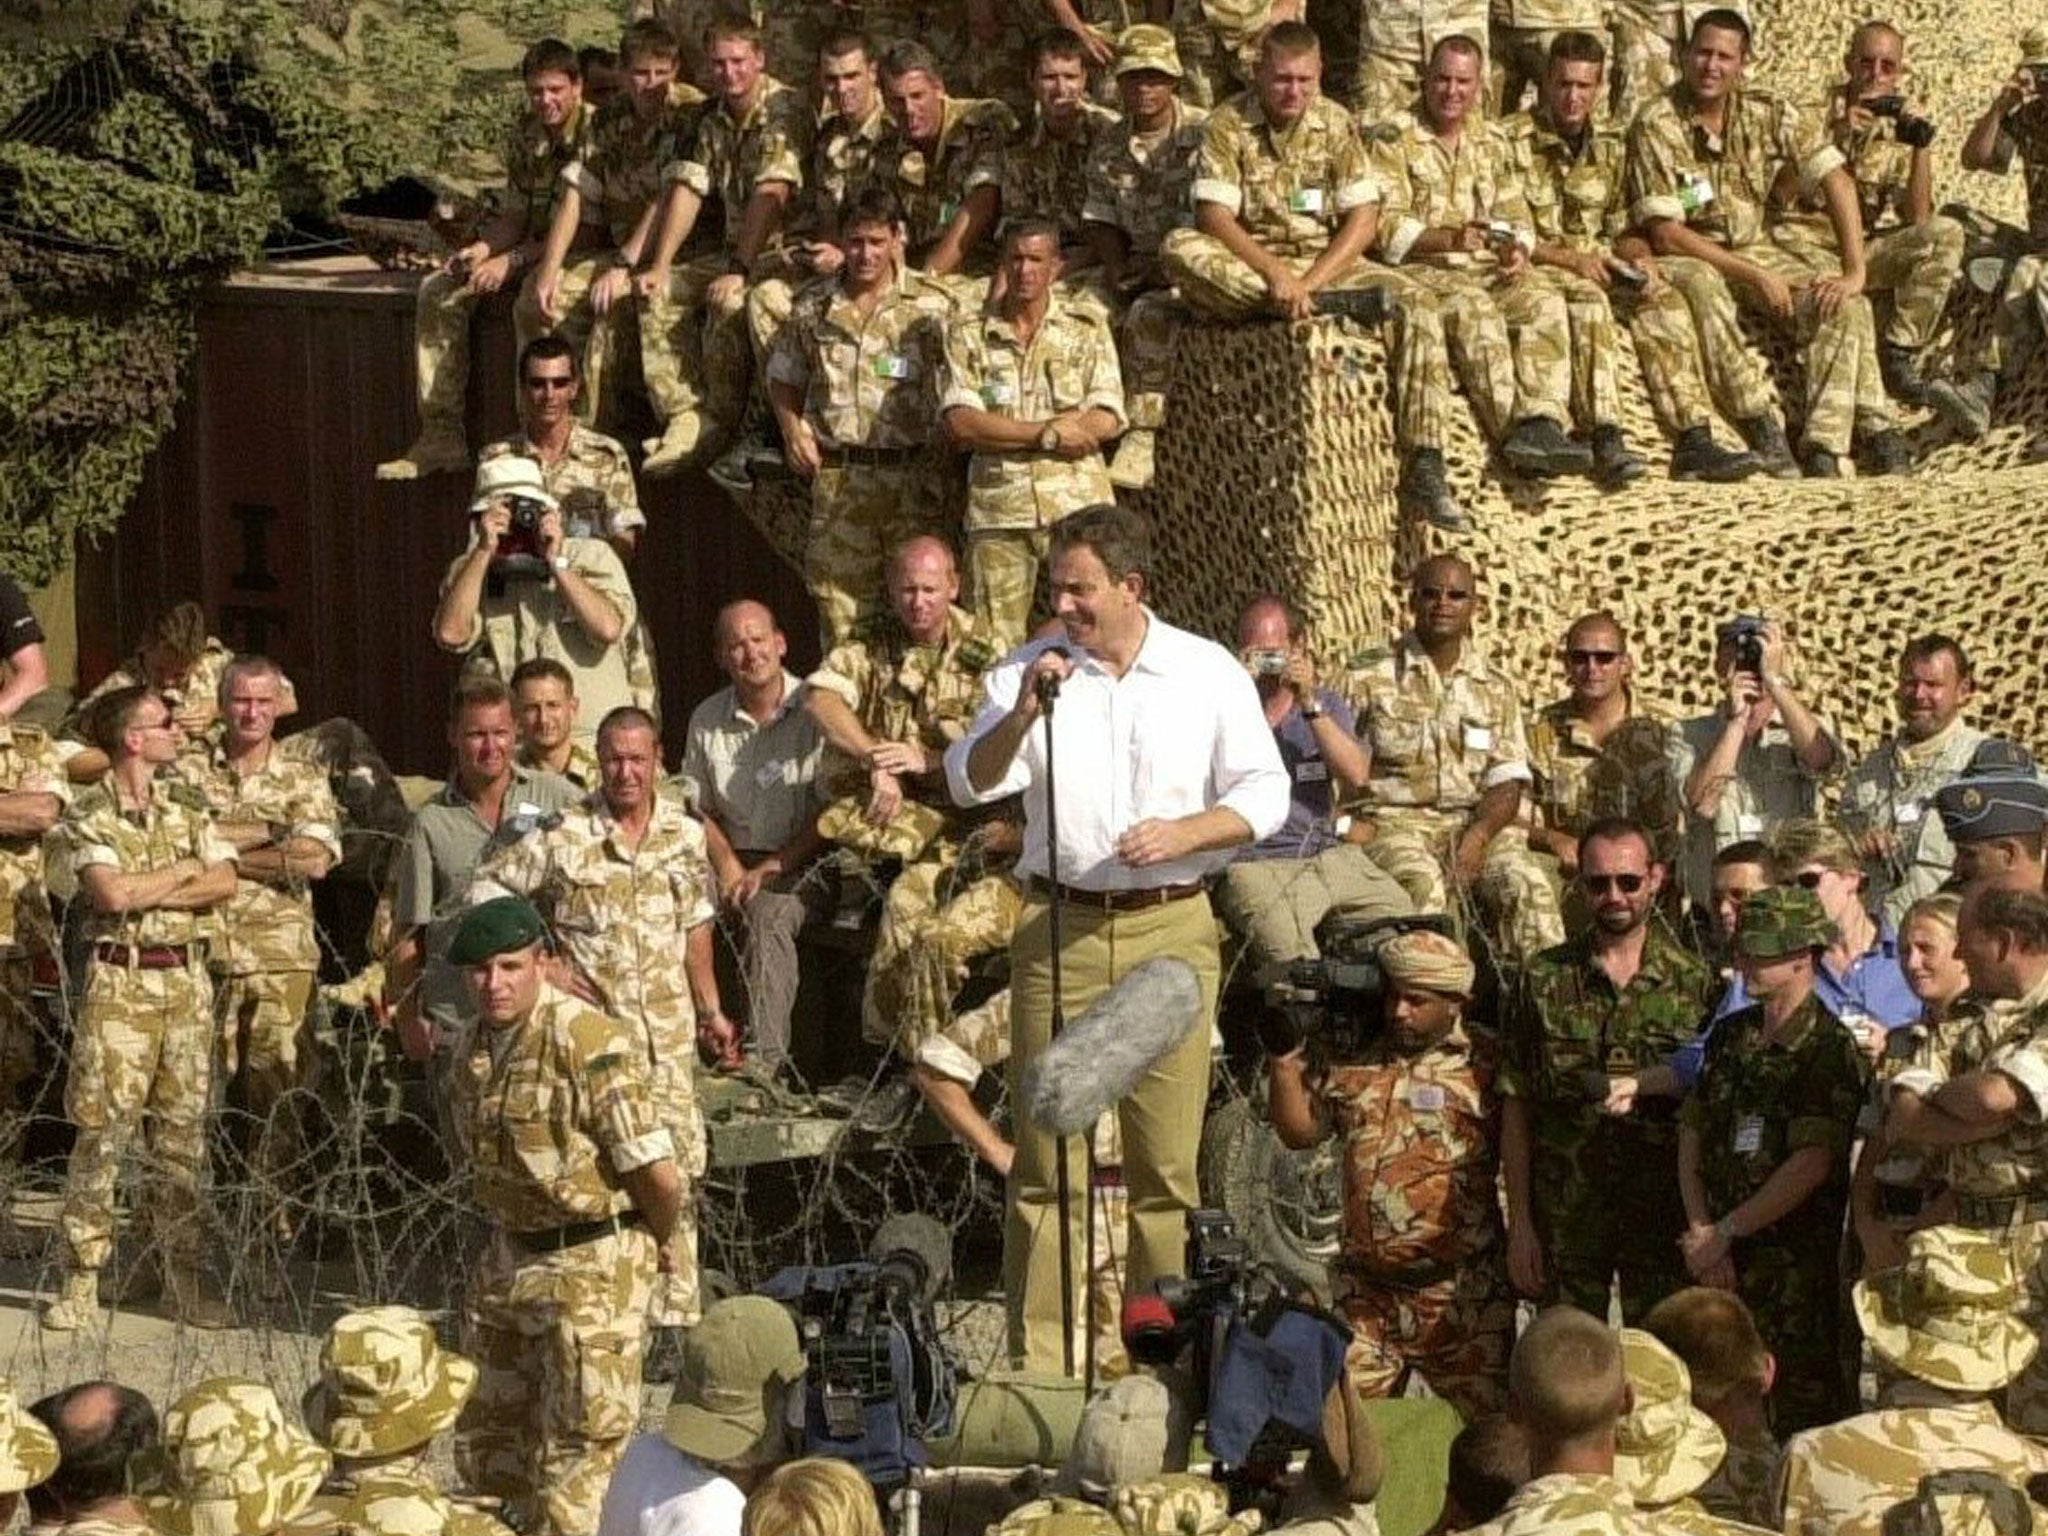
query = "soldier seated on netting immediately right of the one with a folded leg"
(1372, 33, 1605, 485)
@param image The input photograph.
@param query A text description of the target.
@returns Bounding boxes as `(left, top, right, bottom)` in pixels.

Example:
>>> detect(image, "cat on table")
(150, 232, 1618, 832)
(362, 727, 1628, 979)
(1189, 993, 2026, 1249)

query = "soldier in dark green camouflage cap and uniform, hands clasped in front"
(1677, 885, 1868, 1434)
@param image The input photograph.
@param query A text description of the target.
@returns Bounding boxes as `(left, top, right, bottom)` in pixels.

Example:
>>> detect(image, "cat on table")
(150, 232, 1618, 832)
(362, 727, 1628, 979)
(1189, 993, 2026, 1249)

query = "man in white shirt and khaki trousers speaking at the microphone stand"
(946, 506, 1288, 1370)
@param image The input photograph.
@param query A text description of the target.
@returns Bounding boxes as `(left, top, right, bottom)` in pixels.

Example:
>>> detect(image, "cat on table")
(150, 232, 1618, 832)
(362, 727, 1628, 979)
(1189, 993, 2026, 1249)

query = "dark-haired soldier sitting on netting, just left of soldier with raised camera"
(1626, 8, 1913, 479)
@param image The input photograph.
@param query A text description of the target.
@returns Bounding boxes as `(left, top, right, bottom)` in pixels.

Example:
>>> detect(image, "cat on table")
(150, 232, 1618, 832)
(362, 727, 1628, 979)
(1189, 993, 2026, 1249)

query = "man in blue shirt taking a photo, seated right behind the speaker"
(1217, 596, 1415, 965)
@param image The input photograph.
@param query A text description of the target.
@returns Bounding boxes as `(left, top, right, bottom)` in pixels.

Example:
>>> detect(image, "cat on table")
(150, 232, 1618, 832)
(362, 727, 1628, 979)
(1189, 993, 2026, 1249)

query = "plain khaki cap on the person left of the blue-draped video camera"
(662, 1296, 803, 1464)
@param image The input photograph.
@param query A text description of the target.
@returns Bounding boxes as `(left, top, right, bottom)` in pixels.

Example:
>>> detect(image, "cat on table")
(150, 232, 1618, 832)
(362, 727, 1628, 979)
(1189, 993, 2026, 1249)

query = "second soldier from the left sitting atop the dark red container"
(512, 18, 705, 426)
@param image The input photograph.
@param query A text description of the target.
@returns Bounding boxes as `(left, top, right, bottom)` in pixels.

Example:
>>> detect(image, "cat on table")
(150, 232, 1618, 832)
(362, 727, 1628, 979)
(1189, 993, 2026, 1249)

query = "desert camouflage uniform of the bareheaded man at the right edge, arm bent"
(1892, 987, 2048, 1436)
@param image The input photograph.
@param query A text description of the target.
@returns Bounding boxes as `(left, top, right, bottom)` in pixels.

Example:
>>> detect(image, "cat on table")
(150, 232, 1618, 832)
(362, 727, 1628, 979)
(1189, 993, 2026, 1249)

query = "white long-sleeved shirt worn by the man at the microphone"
(946, 610, 1288, 891)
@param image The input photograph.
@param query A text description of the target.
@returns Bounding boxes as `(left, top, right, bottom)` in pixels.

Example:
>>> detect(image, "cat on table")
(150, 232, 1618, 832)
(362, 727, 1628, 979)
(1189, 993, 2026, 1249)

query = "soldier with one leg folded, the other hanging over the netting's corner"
(1159, 23, 1473, 530)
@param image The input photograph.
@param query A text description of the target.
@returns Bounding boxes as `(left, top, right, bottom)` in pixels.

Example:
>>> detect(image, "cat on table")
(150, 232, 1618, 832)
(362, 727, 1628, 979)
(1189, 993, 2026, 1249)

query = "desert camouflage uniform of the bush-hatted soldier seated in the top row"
(1081, 102, 1208, 430)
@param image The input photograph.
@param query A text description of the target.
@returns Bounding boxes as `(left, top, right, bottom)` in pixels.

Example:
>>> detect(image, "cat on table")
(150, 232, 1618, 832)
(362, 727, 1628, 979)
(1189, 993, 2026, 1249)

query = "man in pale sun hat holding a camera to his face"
(434, 459, 639, 741)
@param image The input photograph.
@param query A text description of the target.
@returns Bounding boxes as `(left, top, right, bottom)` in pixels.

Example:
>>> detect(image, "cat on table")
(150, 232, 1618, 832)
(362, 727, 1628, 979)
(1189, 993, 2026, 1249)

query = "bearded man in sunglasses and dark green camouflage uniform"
(1501, 821, 1714, 1323)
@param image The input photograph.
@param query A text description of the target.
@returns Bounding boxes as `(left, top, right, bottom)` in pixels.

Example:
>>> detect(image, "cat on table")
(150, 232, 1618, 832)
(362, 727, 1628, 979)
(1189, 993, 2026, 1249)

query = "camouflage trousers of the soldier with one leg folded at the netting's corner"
(1159, 229, 1449, 453)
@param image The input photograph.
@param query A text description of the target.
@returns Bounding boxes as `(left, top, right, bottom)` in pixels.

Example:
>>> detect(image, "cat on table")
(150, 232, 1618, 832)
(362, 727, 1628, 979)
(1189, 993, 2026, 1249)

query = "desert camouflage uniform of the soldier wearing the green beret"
(455, 985, 674, 1536)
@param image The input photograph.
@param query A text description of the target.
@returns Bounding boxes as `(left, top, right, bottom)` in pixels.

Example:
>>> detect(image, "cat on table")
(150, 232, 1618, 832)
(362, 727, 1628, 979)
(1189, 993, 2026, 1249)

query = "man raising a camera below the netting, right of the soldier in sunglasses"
(1671, 614, 1841, 907)
